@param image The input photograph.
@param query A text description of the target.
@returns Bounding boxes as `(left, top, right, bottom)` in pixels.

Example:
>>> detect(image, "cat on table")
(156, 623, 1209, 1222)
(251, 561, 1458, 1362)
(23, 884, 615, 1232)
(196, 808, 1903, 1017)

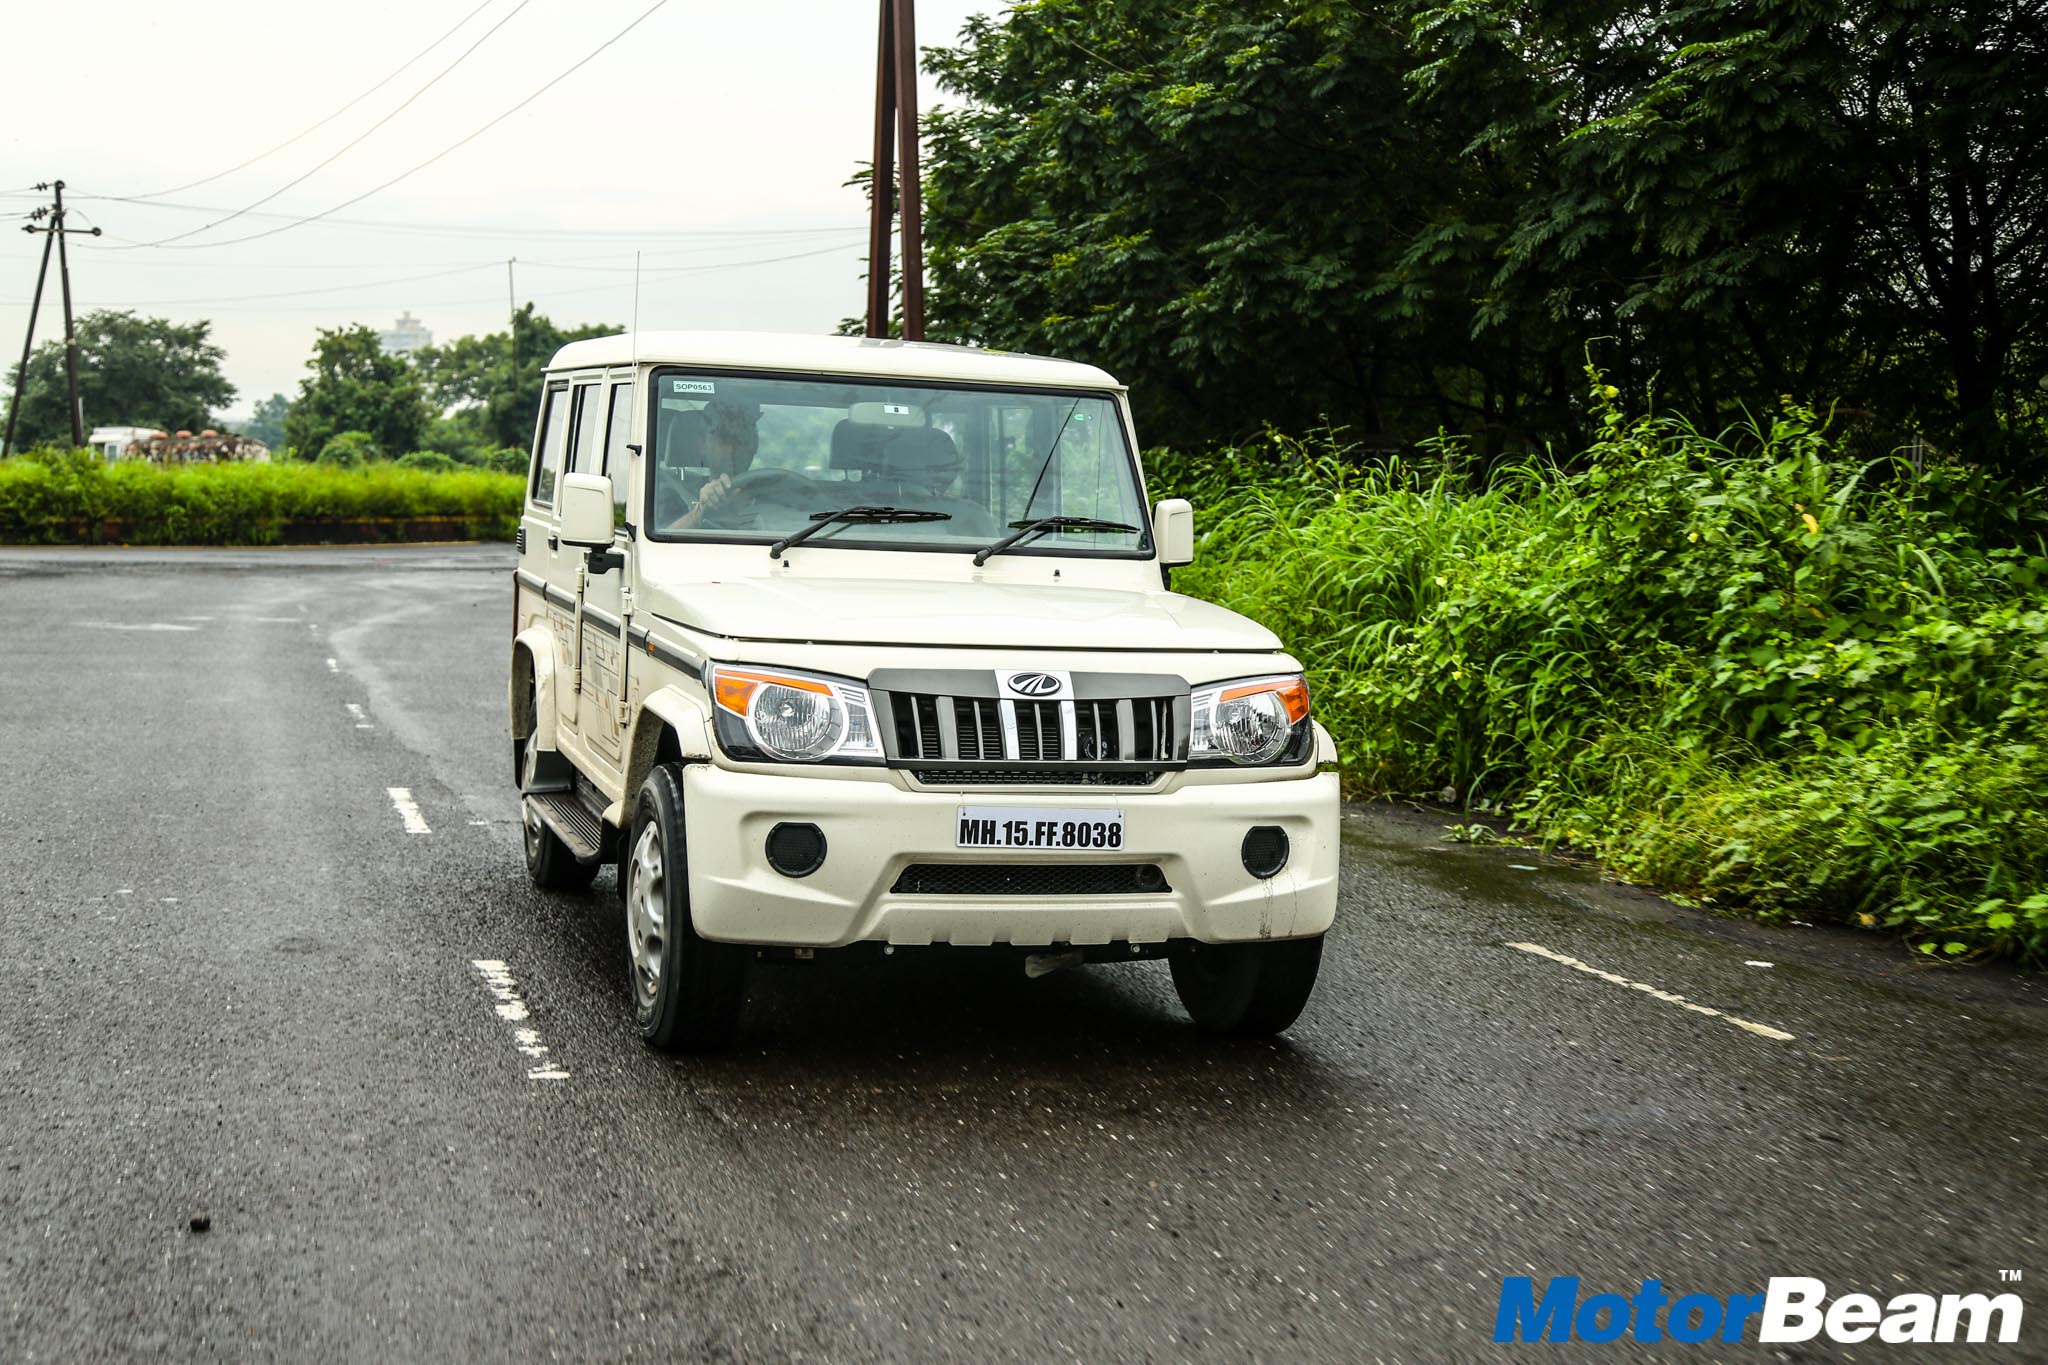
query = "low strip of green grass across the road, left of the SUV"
(0, 450, 522, 544)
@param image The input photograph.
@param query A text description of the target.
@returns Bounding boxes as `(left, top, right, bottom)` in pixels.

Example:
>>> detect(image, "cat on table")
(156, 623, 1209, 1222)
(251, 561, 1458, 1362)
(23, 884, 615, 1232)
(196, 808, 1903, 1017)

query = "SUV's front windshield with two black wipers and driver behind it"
(645, 368, 1151, 557)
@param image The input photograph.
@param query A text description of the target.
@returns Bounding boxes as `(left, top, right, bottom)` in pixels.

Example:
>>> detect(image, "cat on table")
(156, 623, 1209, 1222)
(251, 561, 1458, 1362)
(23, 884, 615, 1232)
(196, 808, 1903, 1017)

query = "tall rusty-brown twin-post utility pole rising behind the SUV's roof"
(868, 0, 924, 342)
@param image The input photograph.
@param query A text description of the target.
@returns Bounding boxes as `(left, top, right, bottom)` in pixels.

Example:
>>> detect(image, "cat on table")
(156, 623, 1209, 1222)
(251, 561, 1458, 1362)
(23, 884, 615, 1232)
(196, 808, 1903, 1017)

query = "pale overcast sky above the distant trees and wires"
(0, 0, 1008, 424)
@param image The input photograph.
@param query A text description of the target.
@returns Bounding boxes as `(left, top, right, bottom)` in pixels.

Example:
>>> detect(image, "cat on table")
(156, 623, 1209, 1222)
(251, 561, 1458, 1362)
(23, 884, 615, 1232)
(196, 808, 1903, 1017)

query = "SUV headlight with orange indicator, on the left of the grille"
(705, 663, 883, 763)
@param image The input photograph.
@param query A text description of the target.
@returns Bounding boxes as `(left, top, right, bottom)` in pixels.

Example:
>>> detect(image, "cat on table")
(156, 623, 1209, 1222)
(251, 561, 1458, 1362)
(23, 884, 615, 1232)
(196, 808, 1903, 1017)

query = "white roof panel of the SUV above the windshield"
(547, 332, 1122, 389)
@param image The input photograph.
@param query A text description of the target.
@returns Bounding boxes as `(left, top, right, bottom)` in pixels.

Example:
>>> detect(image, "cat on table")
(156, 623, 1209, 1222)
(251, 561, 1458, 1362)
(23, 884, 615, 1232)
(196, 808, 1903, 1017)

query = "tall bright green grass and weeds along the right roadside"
(1155, 387, 2048, 960)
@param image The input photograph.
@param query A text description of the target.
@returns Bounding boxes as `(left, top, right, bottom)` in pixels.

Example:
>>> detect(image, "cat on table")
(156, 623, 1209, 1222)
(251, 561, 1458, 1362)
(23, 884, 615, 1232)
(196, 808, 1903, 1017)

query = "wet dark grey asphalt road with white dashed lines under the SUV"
(0, 546, 2048, 1361)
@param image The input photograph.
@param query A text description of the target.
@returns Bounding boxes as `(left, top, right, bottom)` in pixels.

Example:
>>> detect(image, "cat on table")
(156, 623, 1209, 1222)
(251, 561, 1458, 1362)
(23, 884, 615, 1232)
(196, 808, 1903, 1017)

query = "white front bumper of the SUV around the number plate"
(682, 763, 1337, 948)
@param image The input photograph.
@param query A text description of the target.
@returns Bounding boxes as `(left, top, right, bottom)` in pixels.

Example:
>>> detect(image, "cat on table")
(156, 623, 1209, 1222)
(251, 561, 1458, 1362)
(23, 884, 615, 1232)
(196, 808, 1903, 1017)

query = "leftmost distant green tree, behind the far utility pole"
(8, 309, 236, 446)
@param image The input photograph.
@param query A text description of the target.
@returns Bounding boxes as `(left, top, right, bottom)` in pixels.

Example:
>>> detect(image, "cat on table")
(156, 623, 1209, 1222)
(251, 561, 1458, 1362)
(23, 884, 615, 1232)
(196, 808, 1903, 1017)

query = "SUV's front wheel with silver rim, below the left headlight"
(623, 763, 750, 1052)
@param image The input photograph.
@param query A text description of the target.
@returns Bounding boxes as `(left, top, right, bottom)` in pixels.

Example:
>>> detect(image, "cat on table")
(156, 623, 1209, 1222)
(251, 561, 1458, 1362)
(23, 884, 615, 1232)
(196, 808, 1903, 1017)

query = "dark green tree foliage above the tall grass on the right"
(926, 0, 2048, 473)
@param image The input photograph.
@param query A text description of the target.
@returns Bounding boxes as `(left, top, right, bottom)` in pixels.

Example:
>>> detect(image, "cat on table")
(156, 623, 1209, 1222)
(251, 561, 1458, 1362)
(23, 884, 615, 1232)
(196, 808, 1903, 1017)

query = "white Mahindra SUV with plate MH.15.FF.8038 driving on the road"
(512, 334, 1337, 1048)
